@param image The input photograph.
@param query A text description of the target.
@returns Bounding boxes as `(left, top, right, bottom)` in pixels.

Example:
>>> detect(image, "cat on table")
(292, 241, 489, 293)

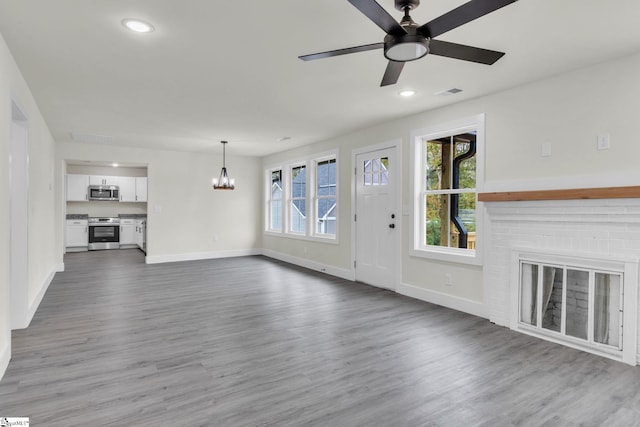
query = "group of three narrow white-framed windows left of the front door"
(264, 152, 338, 242)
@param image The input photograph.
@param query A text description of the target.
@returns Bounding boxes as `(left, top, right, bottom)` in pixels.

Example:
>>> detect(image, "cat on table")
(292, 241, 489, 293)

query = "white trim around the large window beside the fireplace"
(409, 114, 485, 265)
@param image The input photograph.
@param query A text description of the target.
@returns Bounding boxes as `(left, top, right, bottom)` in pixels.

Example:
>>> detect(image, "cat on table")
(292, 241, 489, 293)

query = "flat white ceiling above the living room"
(0, 0, 640, 155)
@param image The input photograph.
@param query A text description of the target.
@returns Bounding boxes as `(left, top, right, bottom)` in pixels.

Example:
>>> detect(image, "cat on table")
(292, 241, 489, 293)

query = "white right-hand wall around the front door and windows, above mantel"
(263, 50, 640, 316)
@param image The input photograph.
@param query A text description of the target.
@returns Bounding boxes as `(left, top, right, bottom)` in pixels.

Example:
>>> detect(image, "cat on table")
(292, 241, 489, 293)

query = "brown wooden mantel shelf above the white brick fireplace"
(478, 186, 640, 202)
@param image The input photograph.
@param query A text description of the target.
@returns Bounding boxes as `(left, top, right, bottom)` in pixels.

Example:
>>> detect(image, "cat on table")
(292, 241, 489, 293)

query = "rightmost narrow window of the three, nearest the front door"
(315, 158, 338, 236)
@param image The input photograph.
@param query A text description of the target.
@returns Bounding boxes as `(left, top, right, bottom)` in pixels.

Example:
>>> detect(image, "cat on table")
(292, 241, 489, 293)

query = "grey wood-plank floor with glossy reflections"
(0, 250, 640, 427)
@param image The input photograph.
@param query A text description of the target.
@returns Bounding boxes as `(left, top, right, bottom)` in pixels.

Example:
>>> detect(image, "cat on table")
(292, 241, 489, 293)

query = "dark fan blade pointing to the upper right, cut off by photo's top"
(417, 0, 518, 38)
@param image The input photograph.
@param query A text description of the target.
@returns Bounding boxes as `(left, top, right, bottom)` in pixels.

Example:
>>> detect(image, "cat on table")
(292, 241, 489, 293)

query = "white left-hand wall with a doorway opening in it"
(0, 36, 60, 376)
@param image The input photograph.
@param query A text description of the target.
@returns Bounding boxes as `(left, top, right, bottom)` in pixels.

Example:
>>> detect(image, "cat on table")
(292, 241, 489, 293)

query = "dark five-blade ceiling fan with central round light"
(298, 0, 517, 86)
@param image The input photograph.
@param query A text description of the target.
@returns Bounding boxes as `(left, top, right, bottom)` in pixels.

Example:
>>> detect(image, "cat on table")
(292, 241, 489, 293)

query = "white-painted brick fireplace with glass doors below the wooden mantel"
(480, 196, 640, 365)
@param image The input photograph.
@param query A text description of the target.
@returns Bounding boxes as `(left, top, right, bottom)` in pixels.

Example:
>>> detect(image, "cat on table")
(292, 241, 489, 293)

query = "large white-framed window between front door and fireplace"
(412, 116, 484, 263)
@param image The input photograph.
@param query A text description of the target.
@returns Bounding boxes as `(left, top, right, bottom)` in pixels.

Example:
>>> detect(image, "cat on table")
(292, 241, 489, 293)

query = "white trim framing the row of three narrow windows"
(263, 149, 340, 245)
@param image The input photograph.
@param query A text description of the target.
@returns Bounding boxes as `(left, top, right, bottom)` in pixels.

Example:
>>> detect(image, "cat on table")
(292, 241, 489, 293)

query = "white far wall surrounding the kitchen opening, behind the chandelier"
(56, 143, 262, 263)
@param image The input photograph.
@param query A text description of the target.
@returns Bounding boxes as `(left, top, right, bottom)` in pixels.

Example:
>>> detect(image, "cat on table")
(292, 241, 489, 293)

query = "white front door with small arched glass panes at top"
(355, 147, 400, 289)
